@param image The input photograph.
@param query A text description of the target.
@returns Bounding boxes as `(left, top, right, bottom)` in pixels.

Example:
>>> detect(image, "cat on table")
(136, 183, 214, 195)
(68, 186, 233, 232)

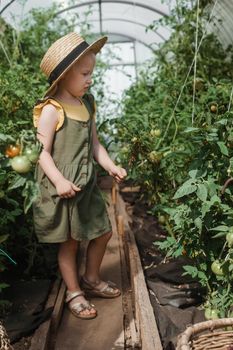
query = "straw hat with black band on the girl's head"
(40, 32, 107, 96)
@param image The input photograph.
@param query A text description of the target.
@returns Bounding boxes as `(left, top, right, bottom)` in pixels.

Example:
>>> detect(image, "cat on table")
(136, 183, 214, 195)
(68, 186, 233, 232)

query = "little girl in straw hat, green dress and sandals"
(33, 33, 127, 319)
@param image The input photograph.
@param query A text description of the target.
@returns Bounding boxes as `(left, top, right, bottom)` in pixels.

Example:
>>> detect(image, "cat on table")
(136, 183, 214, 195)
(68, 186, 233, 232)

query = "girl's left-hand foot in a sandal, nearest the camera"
(66, 291, 97, 320)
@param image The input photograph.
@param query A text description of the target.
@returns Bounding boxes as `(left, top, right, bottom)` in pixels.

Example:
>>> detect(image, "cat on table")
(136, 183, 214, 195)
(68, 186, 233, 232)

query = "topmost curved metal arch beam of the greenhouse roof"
(55, 0, 168, 17)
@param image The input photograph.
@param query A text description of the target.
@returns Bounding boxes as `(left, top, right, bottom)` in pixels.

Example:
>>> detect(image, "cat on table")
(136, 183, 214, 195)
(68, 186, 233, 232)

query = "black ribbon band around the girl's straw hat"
(48, 41, 89, 85)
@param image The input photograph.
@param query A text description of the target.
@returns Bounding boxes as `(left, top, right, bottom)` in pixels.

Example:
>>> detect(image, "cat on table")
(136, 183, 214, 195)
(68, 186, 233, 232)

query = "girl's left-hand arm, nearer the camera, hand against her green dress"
(37, 104, 80, 198)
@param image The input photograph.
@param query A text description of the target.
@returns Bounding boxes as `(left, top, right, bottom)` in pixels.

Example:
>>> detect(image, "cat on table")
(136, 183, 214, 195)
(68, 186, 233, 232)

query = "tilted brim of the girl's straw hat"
(44, 36, 108, 97)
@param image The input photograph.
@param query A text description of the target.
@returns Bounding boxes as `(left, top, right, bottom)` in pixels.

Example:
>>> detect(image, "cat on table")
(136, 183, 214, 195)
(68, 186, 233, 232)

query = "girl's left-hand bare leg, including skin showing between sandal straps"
(58, 238, 96, 315)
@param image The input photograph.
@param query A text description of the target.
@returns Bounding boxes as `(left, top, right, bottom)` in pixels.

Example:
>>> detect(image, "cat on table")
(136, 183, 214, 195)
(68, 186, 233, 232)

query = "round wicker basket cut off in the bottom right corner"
(176, 318, 233, 350)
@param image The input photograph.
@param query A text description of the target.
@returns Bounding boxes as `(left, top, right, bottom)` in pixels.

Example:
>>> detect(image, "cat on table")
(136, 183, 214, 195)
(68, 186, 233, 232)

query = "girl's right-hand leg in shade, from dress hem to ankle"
(85, 232, 112, 282)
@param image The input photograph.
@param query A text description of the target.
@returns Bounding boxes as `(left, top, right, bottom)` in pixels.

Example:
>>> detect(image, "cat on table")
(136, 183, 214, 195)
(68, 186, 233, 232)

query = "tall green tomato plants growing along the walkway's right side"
(115, 0, 233, 315)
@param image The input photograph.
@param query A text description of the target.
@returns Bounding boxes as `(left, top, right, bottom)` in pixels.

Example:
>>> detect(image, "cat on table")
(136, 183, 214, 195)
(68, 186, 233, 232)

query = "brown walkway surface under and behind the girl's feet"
(55, 196, 125, 350)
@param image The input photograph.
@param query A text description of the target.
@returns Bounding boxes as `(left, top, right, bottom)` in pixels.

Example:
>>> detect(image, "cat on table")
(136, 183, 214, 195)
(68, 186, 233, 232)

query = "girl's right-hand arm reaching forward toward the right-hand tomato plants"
(92, 123, 127, 183)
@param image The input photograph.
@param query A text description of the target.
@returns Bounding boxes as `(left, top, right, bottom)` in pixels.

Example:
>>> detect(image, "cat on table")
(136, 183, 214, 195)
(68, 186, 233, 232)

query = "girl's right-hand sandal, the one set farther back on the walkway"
(80, 276, 121, 298)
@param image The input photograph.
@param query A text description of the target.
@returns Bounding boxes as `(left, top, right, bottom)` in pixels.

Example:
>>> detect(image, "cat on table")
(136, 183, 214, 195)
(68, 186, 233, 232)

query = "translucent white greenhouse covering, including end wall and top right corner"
(0, 0, 233, 98)
